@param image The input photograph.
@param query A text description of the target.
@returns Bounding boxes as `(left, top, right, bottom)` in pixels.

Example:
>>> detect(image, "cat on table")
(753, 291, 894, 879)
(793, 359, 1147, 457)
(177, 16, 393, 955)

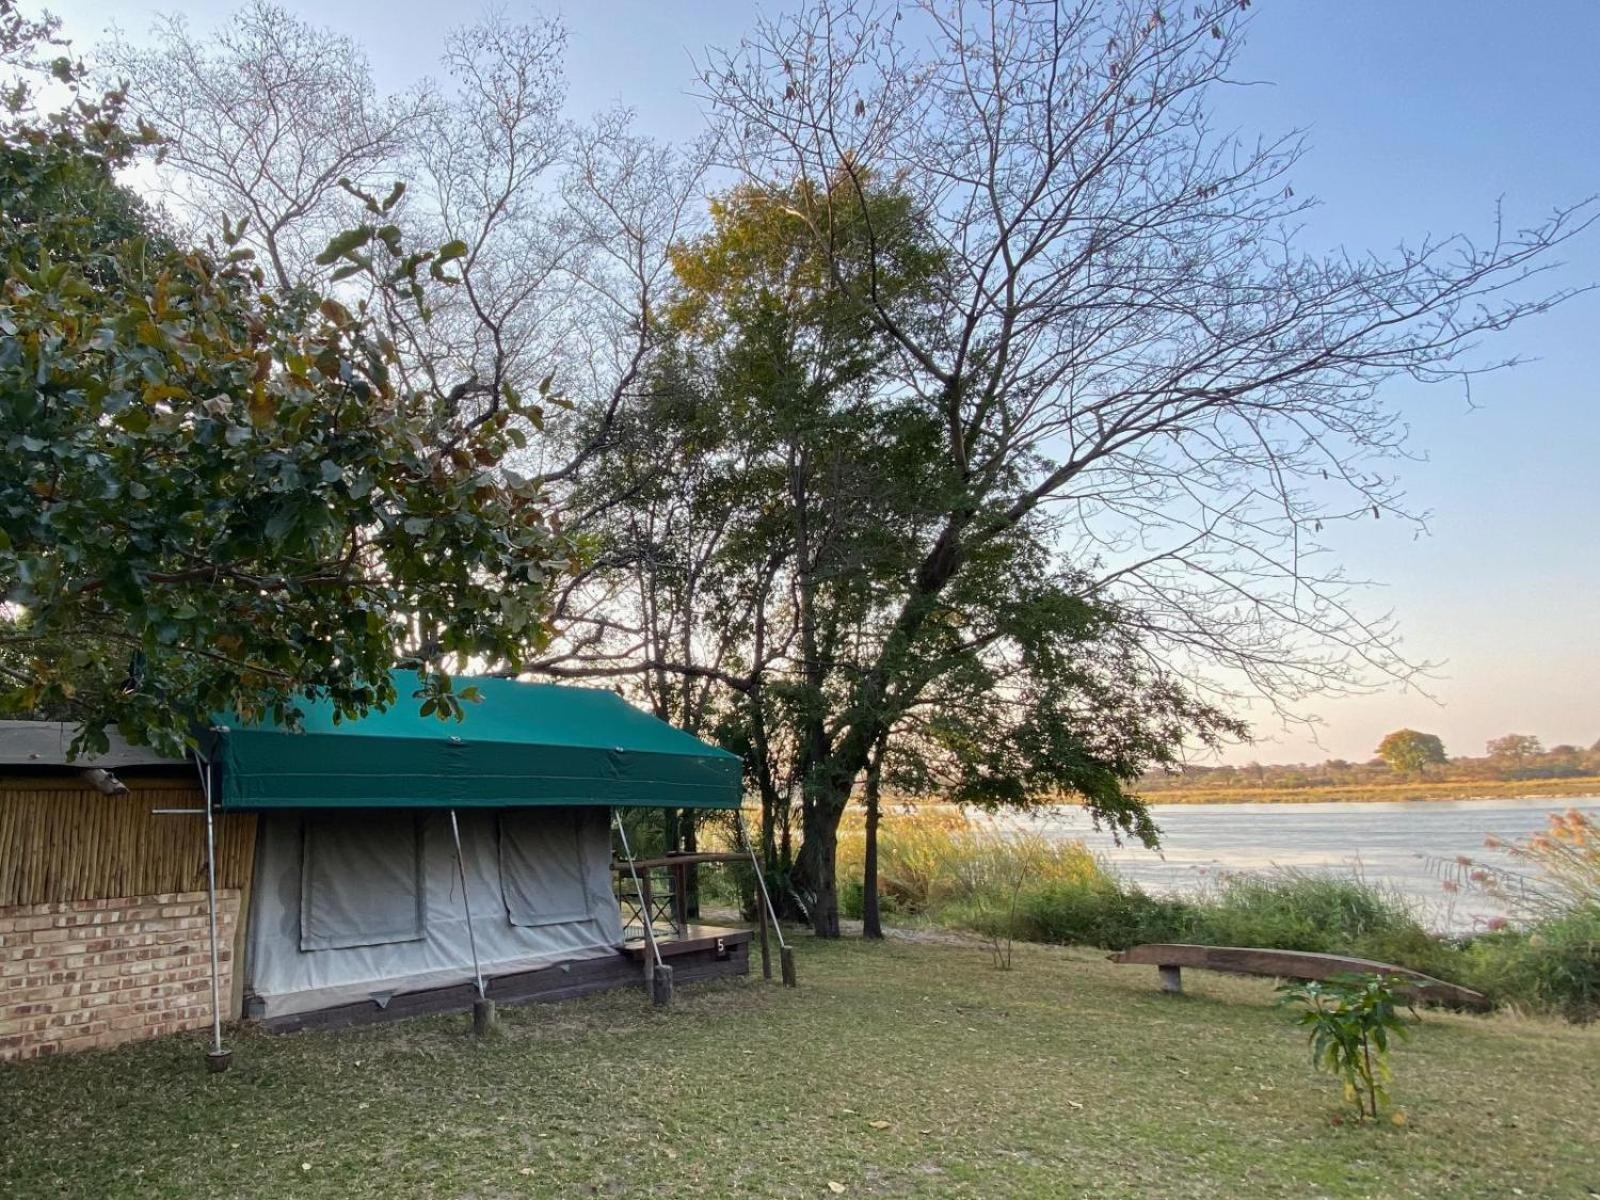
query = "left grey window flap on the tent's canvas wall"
(301, 811, 424, 950)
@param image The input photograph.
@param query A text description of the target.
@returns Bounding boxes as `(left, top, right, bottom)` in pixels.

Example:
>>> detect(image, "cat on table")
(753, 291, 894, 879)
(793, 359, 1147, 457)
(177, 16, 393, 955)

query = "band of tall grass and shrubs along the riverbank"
(819, 806, 1600, 1021)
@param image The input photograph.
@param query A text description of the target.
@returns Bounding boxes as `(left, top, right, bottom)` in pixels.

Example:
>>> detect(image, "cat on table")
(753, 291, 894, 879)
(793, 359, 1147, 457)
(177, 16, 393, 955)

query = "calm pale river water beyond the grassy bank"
(998, 797, 1600, 933)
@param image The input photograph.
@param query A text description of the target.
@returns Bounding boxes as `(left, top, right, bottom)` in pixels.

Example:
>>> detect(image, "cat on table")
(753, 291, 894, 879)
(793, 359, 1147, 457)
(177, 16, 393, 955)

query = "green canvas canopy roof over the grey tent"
(213, 678, 742, 810)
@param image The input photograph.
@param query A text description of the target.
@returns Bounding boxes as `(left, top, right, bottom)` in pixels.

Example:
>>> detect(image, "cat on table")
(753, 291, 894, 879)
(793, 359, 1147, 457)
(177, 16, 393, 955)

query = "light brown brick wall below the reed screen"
(0, 888, 238, 1059)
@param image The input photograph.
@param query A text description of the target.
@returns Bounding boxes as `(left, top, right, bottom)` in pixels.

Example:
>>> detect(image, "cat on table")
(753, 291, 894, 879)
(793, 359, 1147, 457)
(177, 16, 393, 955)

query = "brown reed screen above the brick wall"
(0, 778, 256, 906)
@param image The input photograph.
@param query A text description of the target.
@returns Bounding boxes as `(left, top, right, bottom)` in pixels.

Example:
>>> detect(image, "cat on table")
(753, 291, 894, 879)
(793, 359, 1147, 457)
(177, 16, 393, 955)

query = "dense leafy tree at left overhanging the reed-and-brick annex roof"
(0, 0, 568, 749)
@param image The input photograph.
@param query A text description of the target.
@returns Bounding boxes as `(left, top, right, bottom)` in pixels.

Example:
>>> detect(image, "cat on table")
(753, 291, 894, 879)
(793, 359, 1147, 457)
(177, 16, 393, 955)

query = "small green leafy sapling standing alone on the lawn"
(1278, 974, 1408, 1123)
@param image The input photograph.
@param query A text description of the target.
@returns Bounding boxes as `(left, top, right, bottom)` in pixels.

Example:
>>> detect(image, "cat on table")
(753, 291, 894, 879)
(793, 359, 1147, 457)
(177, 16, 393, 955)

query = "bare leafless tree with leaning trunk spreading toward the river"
(672, 0, 1595, 931)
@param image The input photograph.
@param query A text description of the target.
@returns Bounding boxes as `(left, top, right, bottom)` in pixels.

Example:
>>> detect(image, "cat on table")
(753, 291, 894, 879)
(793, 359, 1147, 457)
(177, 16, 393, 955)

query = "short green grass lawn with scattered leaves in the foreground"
(0, 939, 1600, 1200)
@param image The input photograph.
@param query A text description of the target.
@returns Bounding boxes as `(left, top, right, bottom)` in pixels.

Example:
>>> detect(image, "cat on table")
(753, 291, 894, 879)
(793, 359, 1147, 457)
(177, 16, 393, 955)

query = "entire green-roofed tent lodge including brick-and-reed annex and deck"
(0, 678, 750, 1058)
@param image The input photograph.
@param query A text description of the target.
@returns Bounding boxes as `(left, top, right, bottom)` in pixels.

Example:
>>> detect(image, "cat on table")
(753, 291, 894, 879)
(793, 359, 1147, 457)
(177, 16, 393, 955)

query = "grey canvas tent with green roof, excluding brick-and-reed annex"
(219, 678, 741, 1022)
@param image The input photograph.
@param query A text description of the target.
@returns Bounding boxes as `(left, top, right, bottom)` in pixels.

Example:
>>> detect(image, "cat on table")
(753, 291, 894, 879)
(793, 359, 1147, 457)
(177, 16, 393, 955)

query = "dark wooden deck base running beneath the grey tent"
(246, 925, 752, 1034)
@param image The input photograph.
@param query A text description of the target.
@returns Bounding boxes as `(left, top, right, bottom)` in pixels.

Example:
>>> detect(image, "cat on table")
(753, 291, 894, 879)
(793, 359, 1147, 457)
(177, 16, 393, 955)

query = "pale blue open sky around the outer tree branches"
(53, 0, 1600, 762)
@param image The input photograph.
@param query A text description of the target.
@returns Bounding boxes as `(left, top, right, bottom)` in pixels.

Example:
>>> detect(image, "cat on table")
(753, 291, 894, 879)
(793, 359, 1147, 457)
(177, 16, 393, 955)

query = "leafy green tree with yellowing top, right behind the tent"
(553, 179, 1237, 933)
